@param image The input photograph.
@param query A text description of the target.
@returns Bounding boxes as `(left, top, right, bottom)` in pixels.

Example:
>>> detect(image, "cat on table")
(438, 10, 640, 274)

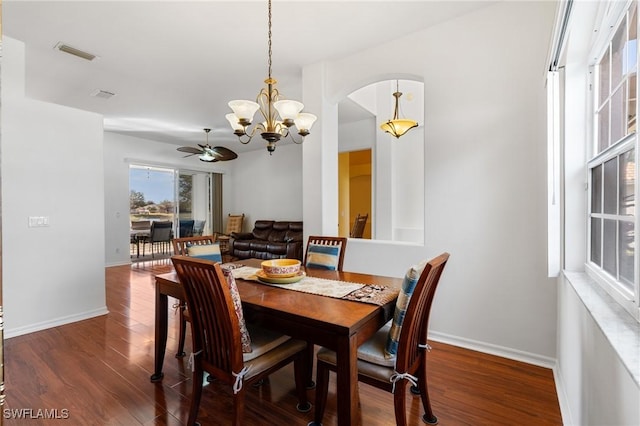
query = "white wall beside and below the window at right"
(555, 2, 640, 425)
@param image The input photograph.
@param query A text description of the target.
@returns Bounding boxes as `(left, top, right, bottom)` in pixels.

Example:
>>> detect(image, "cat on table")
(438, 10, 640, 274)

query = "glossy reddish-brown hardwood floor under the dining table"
(3, 260, 562, 426)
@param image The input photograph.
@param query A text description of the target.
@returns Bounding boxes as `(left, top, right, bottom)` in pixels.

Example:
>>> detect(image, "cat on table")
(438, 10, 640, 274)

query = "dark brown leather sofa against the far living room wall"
(229, 220, 303, 260)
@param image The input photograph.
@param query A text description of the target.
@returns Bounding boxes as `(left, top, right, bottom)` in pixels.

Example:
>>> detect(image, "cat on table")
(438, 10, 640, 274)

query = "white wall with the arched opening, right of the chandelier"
(304, 2, 556, 366)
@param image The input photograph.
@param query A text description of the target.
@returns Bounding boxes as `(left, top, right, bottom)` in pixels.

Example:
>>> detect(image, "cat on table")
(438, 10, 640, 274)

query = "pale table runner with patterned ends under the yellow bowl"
(224, 264, 398, 306)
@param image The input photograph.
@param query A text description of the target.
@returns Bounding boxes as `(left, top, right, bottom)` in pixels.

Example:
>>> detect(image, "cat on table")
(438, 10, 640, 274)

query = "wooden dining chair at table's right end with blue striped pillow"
(310, 253, 449, 426)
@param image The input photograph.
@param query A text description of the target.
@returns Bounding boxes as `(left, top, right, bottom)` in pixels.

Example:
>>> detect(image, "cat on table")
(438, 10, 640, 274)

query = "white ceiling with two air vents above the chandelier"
(2, 0, 492, 152)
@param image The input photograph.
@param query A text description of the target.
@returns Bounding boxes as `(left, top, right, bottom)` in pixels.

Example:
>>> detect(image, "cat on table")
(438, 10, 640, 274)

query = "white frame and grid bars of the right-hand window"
(585, 0, 640, 321)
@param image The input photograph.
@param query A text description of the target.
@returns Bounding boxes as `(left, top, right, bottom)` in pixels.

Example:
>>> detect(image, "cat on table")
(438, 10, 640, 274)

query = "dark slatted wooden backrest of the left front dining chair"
(171, 256, 244, 385)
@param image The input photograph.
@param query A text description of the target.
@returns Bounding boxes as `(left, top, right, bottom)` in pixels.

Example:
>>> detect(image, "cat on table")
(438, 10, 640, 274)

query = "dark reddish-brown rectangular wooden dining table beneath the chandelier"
(151, 259, 402, 425)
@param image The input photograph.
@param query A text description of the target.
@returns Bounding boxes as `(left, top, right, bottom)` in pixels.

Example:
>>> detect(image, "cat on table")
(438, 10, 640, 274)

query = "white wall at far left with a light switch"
(1, 37, 107, 337)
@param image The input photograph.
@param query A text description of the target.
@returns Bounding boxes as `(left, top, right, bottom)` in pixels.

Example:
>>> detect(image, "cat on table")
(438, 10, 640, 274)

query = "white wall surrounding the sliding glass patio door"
(104, 132, 236, 266)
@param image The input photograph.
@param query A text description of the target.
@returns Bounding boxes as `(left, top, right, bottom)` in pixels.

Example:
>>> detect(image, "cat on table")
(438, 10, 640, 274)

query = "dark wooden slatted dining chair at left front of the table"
(171, 256, 311, 426)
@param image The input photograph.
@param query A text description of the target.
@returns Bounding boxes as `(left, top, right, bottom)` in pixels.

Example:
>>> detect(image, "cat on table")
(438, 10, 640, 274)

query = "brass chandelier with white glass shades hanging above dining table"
(226, 0, 317, 155)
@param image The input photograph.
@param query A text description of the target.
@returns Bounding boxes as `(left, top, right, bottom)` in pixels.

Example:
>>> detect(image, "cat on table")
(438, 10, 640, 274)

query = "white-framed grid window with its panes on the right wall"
(587, 2, 640, 317)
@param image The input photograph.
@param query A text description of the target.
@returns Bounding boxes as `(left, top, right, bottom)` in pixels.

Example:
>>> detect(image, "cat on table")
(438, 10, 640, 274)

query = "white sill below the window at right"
(564, 271, 640, 385)
